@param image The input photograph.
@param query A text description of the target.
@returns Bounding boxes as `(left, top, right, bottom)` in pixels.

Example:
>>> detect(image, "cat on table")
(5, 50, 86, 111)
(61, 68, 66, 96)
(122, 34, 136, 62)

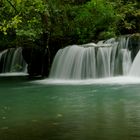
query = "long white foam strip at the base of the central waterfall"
(35, 76, 140, 85)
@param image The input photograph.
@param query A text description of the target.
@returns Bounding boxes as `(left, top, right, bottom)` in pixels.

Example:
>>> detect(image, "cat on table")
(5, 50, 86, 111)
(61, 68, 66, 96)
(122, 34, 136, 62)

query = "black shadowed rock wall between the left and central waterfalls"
(22, 38, 62, 77)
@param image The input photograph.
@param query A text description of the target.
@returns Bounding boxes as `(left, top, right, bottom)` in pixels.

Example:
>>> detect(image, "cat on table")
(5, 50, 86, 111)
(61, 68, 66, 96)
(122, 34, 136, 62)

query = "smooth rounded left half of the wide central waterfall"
(50, 45, 96, 79)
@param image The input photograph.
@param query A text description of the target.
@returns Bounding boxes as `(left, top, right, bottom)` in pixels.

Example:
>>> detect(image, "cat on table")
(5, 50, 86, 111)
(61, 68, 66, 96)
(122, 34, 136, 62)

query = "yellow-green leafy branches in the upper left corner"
(0, 0, 47, 40)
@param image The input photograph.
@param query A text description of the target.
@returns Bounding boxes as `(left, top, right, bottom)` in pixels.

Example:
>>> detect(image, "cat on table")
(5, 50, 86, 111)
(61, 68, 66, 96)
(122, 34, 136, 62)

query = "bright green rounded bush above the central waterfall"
(75, 0, 116, 41)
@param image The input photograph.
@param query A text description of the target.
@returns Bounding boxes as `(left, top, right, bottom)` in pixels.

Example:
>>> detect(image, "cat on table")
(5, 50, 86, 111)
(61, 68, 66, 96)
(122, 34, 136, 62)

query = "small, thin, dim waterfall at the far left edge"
(0, 48, 27, 73)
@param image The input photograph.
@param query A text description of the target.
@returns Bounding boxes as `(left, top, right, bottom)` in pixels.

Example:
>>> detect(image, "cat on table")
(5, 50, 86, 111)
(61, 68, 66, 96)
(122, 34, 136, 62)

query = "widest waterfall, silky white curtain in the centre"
(49, 37, 132, 79)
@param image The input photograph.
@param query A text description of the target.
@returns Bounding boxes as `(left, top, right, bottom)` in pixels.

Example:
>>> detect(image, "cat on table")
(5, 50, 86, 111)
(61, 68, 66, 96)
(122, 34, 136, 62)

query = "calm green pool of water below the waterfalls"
(0, 77, 140, 140)
